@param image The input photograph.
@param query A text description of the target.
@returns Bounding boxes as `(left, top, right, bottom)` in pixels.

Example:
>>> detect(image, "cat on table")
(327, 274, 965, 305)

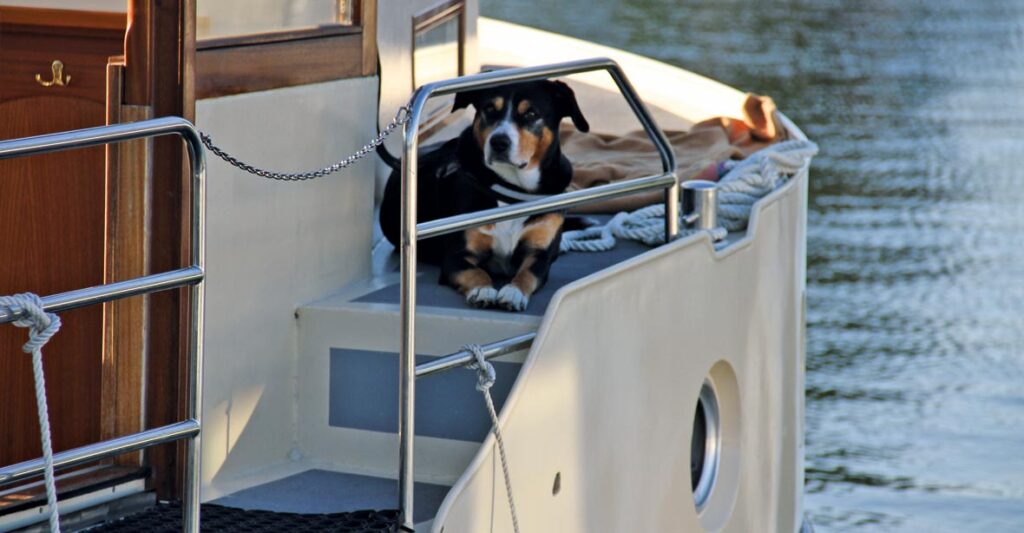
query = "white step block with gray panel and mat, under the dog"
(296, 237, 649, 485)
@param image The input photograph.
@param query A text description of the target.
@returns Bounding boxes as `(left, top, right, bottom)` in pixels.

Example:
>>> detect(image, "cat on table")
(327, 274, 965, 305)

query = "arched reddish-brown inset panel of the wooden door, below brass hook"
(0, 96, 104, 464)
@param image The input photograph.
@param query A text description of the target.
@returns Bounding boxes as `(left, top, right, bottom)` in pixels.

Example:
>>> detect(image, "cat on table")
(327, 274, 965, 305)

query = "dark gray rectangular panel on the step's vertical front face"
(328, 348, 521, 442)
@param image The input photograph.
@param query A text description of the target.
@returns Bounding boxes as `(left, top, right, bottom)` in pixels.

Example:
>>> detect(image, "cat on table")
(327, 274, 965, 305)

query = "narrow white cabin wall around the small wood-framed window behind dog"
(377, 0, 480, 198)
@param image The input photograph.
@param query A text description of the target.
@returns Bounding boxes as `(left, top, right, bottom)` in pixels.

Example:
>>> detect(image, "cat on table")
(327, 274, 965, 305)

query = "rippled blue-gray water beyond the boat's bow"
(481, 0, 1024, 532)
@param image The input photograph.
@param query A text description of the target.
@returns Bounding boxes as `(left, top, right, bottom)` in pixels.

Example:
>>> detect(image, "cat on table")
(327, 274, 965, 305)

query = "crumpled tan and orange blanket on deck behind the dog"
(560, 94, 787, 213)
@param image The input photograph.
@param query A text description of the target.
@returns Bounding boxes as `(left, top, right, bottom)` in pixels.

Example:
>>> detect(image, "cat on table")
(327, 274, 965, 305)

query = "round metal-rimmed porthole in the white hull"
(690, 380, 722, 513)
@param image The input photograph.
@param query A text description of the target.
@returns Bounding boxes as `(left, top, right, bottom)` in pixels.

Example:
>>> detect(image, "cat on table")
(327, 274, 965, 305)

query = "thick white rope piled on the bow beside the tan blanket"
(561, 140, 818, 253)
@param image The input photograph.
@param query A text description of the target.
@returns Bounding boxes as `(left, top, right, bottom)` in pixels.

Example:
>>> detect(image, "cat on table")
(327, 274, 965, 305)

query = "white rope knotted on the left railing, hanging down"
(0, 293, 60, 533)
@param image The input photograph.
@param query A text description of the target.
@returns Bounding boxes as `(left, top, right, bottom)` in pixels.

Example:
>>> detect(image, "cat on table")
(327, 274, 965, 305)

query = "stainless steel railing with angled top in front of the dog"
(398, 58, 679, 531)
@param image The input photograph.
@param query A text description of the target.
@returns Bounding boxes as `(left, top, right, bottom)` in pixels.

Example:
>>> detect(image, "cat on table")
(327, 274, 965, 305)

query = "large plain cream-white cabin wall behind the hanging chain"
(196, 77, 377, 500)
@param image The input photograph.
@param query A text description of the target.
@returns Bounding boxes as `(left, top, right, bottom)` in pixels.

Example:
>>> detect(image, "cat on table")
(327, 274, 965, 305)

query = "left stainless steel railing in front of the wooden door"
(0, 117, 206, 533)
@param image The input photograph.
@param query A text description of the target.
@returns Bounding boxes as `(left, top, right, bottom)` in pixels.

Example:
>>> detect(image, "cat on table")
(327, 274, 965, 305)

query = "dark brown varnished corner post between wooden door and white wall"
(124, 0, 196, 498)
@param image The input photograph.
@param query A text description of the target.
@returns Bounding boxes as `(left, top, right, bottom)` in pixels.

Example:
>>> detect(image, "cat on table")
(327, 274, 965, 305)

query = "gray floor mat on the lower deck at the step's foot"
(210, 470, 449, 522)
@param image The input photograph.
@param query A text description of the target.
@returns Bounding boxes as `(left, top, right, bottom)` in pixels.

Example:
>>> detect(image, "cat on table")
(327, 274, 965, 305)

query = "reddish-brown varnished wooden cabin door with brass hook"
(0, 7, 124, 464)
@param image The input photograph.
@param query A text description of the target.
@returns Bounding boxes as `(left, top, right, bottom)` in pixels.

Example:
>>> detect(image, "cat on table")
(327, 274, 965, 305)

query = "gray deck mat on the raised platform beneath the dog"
(355, 235, 651, 316)
